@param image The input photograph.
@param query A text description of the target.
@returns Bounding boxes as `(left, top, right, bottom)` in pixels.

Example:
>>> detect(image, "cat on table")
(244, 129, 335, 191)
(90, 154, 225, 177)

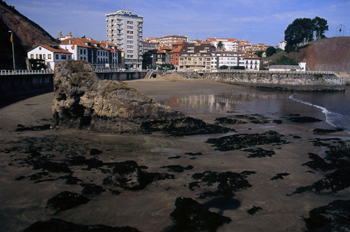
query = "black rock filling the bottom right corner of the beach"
(304, 200, 350, 232)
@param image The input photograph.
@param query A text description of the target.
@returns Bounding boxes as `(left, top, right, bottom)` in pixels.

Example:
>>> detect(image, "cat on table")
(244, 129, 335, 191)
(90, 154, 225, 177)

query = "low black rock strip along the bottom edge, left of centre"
(23, 218, 139, 232)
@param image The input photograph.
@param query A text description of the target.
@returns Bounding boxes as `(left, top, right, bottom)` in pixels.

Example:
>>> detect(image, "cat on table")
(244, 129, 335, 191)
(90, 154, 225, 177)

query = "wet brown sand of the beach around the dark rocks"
(0, 79, 350, 232)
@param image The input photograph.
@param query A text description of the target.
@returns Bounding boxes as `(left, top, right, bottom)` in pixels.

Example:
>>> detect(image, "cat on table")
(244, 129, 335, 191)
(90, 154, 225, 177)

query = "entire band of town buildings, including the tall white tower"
(27, 10, 285, 71)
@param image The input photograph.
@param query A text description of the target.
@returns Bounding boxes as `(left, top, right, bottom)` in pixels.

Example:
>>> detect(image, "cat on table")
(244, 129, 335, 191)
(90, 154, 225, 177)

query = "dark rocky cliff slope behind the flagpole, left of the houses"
(0, 0, 58, 69)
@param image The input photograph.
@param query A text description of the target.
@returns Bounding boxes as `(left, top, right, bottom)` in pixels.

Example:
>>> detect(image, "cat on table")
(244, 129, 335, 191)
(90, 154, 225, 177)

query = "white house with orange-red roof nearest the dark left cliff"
(27, 45, 72, 70)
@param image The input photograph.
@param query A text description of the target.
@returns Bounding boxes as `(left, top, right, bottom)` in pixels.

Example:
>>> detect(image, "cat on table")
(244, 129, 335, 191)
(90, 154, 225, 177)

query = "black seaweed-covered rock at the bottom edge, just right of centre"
(168, 197, 231, 232)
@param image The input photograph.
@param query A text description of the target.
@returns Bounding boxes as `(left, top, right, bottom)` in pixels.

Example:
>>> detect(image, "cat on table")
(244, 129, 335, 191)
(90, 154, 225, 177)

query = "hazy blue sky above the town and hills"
(4, 0, 350, 45)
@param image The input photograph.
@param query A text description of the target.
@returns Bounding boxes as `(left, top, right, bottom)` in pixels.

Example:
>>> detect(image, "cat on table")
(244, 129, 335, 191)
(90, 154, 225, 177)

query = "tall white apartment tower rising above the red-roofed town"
(106, 10, 143, 69)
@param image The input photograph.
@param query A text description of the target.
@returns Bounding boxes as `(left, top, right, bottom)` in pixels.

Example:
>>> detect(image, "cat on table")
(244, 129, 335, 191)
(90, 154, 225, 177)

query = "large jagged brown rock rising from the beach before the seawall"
(52, 60, 229, 136)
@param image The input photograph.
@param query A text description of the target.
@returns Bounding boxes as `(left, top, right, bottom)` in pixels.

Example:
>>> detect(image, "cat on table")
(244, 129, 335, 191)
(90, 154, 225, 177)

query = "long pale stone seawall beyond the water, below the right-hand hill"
(175, 71, 346, 91)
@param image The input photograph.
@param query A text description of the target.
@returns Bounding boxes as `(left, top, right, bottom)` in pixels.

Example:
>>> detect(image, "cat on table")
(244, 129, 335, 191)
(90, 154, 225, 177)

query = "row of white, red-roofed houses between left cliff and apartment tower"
(27, 37, 124, 70)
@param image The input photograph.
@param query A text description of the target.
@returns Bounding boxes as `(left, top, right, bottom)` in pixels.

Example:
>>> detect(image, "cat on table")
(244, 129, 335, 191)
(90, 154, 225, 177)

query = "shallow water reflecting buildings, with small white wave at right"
(158, 87, 350, 133)
